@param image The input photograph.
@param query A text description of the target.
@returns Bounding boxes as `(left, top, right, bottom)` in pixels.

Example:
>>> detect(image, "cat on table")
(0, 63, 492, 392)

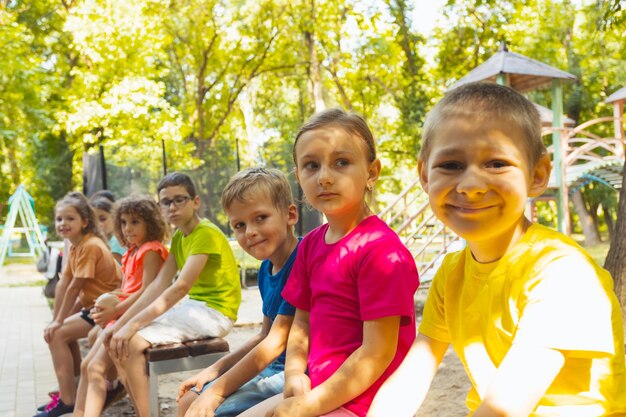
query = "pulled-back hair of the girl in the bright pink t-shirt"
(293, 108, 376, 166)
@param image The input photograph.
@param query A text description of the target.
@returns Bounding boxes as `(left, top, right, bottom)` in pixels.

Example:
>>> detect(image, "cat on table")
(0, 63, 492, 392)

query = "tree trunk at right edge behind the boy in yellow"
(604, 162, 626, 338)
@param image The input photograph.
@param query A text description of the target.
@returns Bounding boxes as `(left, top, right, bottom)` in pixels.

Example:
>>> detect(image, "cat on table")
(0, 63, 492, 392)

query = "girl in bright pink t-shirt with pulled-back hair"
(243, 109, 419, 417)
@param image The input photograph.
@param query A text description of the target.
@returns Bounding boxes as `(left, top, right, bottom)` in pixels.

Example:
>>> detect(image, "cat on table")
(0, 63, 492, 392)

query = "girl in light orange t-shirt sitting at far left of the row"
(39, 192, 121, 417)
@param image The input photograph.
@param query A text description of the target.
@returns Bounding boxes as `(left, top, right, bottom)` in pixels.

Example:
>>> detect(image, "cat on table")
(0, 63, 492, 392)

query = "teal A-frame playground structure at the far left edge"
(0, 185, 47, 267)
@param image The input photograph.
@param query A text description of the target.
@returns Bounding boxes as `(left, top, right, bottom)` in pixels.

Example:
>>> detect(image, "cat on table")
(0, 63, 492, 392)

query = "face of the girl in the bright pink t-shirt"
(295, 126, 380, 221)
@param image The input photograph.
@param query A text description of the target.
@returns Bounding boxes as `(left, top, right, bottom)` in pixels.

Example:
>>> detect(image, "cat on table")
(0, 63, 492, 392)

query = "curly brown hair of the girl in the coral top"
(114, 196, 168, 247)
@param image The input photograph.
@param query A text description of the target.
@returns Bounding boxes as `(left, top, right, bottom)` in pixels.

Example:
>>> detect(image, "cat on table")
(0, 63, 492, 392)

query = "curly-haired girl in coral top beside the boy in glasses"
(74, 197, 168, 417)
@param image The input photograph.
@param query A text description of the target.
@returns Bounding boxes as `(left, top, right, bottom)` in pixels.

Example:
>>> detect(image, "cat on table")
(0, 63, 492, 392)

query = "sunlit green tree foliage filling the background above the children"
(0, 0, 626, 231)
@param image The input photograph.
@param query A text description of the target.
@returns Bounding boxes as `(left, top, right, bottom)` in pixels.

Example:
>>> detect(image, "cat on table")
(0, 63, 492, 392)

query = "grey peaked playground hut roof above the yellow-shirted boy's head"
(448, 42, 576, 92)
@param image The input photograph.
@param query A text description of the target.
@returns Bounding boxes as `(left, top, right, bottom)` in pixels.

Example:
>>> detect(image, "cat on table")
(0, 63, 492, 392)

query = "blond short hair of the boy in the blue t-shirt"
(222, 168, 294, 212)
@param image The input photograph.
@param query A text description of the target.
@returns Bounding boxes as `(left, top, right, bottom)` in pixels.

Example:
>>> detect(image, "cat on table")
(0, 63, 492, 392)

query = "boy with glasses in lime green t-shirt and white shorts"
(105, 173, 241, 416)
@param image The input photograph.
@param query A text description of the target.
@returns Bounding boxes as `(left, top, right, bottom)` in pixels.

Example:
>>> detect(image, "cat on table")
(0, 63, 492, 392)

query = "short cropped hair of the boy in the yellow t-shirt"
(419, 82, 546, 167)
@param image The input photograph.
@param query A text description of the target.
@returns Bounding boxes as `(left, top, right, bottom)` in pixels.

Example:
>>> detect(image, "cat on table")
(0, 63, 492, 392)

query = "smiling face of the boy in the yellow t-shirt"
(419, 117, 550, 262)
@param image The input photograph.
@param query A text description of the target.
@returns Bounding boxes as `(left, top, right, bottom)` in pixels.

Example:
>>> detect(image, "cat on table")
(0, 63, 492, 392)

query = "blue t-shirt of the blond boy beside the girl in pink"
(258, 240, 300, 368)
